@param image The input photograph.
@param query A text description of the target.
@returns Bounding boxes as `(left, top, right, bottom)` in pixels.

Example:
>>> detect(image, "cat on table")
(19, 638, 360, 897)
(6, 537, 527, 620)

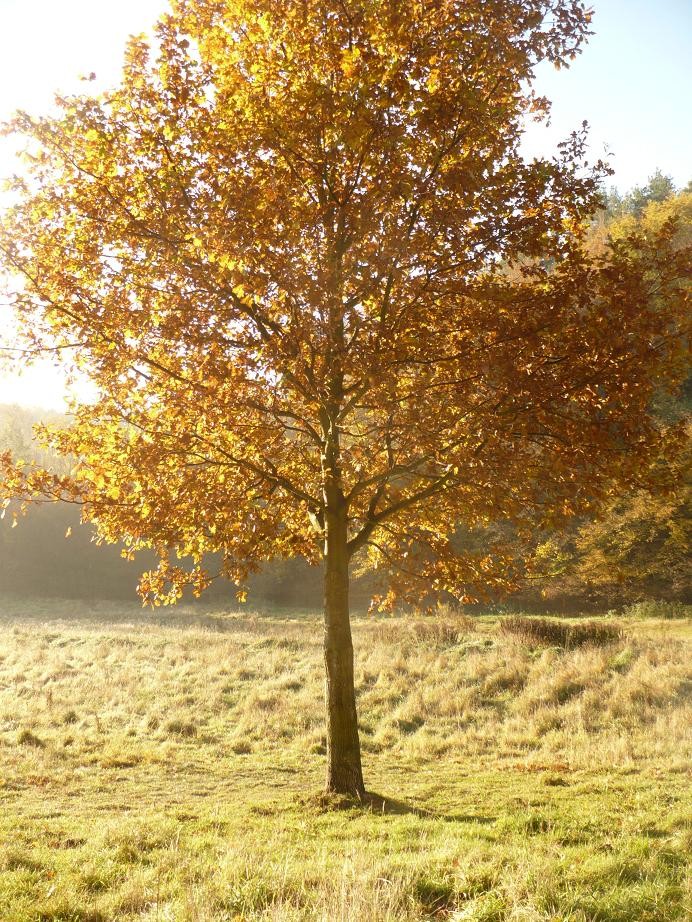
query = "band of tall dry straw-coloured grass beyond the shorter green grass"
(0, 600, 692, 770)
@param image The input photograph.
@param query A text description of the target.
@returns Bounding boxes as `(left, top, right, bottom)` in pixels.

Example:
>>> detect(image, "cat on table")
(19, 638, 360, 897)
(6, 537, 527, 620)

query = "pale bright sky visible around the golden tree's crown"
(0, 0, 692, 409)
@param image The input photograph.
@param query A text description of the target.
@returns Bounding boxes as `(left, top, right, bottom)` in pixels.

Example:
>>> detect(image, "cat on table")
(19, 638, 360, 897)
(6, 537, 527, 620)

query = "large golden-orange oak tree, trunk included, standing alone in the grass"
(0, 0, 682, 796)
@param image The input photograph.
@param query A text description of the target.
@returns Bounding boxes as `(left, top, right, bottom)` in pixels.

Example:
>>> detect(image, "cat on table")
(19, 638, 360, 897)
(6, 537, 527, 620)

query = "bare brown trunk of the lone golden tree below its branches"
(324, 505, 365, 798)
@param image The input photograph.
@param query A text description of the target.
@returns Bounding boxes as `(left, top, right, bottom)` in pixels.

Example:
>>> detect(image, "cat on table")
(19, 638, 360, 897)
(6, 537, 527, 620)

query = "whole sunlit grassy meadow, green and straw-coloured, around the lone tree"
(0, 602, 692, 922)
